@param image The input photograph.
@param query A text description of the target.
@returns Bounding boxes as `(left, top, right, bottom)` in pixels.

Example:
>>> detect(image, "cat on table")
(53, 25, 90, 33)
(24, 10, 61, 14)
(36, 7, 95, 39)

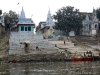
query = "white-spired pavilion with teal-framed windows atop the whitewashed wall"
(17, 7, 35, 32)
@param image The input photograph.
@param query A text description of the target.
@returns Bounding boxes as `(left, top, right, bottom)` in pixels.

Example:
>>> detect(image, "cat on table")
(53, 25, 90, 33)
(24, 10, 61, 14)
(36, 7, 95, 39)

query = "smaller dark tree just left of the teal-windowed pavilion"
(3, 10, 18, 29)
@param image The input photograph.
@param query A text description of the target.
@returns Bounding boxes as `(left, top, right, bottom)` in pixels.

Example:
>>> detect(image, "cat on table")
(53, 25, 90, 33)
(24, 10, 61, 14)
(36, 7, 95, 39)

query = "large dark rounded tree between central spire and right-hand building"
(53, 6, 83, 32)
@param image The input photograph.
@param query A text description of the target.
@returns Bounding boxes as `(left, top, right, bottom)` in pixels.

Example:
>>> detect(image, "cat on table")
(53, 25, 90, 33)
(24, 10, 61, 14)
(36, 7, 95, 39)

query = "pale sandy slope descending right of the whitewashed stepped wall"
(50, 41, 99, 57)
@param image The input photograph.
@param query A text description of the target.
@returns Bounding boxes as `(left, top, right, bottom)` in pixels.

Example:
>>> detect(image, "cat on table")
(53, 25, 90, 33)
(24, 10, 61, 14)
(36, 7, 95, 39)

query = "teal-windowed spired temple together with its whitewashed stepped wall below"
(9, 8, 58, 55)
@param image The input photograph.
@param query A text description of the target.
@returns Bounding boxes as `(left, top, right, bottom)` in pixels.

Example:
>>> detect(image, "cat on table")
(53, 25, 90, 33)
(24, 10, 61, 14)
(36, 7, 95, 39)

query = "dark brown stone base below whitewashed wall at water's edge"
(8, 53, 66, 62)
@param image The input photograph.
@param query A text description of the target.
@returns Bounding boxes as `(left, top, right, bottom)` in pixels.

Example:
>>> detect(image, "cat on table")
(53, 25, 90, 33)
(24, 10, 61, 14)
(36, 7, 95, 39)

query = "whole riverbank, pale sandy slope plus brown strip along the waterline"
(0, 35, 99, 61)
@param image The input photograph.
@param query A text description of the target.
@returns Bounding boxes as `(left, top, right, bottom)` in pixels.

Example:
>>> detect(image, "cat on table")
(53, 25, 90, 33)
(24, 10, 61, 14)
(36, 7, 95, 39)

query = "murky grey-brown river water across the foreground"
(0, 61, 100, 75)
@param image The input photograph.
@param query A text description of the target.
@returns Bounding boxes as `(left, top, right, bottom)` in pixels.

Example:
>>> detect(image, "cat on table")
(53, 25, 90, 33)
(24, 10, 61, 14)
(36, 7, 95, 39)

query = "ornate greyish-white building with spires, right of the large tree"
(82, 9, 99, 36)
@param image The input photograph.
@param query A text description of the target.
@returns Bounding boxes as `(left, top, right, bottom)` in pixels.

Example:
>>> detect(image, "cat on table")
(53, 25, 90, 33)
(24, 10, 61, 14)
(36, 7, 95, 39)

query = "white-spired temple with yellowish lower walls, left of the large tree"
(36, 9, 62, 39)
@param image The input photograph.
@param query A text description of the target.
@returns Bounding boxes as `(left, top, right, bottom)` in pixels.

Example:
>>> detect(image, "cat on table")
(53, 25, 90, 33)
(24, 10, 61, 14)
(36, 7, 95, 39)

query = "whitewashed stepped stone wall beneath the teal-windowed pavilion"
(9, 32, 57, 54)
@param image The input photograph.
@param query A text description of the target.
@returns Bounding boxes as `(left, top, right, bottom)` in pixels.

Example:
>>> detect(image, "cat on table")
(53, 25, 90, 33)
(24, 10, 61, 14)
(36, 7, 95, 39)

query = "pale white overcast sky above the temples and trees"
(0, 0, 100, 25)
